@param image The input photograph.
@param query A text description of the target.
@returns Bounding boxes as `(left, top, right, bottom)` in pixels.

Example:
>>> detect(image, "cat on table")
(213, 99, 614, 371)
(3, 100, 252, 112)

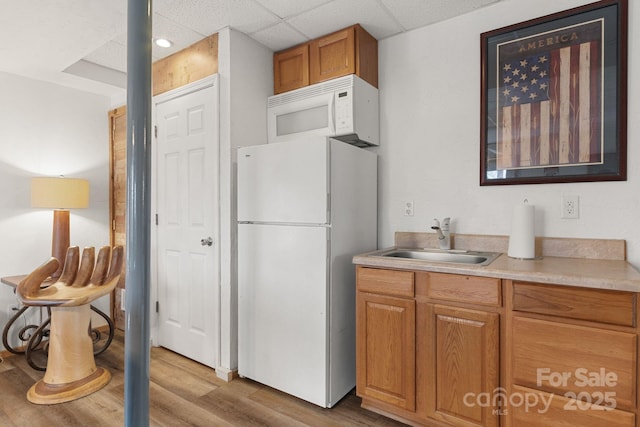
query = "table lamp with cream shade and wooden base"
(31, 177, 89, 279)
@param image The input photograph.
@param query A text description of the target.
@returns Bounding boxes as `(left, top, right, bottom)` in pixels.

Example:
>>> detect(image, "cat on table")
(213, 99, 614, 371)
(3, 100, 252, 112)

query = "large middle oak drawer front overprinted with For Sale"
(512, 316, 637, 410)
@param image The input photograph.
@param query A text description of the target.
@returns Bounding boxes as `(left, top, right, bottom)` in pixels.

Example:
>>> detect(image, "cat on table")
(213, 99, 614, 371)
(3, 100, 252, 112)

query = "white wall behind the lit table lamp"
(0, 72, 110, 344)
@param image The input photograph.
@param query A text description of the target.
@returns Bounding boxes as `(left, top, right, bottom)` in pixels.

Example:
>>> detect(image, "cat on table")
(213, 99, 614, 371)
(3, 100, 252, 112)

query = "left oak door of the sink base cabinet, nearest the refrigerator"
(356, 292, 416, 411)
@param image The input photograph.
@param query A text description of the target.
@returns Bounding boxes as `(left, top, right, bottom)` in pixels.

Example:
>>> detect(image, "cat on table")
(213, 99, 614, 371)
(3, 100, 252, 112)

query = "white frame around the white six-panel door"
(149, 74, 221, 354)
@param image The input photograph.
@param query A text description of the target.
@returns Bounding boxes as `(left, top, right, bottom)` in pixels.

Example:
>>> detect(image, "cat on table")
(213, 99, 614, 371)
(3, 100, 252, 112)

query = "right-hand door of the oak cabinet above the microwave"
(309, 27, 356, 84)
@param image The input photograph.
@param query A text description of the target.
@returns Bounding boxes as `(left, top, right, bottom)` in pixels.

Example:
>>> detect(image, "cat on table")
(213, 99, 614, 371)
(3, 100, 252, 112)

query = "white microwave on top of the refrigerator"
(267, 74, 380, 146)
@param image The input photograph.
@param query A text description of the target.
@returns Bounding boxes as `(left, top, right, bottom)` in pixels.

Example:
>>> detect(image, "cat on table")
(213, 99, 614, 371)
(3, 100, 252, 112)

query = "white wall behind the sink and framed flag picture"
(377, 0, 640, 267)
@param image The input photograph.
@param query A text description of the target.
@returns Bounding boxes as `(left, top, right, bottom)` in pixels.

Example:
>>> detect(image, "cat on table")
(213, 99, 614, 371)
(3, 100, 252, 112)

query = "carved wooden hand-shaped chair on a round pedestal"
(16, 246, 124, 405)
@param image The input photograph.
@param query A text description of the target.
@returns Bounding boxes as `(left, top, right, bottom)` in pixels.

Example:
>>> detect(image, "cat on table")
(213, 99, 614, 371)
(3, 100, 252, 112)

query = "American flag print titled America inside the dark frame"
(496, 21, 603, 170)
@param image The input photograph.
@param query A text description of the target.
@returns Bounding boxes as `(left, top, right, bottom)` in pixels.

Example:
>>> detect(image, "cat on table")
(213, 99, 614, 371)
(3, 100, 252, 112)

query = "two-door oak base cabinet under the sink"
(356, 267, 501, 427)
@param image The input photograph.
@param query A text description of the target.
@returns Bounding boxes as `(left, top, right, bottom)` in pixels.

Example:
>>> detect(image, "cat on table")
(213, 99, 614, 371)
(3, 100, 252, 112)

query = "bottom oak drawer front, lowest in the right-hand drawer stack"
(508, 386, 636, 427)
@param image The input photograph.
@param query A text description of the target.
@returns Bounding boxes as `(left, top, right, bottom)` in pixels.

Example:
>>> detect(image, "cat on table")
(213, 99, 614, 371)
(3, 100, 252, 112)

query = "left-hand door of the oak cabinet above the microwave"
(273, 44, 309, 94)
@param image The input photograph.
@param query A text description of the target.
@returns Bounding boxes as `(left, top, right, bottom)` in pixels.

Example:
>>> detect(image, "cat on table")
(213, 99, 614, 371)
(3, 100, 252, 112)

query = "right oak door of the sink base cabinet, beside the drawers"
(428, 304, 500, 427)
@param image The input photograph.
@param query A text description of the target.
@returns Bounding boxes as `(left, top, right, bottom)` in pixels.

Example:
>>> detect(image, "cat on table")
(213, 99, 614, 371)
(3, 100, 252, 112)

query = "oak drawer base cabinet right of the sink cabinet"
(506, 281, 639, 427)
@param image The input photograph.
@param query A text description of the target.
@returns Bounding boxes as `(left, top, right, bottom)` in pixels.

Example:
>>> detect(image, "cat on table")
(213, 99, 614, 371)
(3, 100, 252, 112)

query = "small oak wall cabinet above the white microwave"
(273, 24, 378, 94)
